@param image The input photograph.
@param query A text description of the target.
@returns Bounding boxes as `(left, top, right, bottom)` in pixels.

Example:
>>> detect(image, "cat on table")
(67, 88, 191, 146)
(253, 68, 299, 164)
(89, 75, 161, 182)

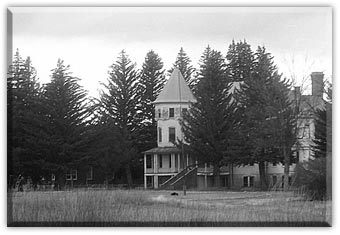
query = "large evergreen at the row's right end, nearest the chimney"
(236, 47, 296, 189)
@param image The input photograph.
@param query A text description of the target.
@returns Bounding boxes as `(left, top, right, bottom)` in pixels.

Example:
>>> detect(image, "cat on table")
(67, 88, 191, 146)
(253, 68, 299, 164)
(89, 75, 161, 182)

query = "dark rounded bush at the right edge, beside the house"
(294, 157, 327, 200)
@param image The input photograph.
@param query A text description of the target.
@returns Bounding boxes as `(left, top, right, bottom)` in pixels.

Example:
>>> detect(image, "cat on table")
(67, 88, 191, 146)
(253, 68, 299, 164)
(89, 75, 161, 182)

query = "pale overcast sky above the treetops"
(10, 7, 332, 96)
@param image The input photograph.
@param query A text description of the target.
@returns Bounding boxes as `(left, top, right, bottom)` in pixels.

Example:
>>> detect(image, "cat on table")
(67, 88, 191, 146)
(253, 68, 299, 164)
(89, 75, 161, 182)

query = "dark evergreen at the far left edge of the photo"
(7, 50, 41, 186)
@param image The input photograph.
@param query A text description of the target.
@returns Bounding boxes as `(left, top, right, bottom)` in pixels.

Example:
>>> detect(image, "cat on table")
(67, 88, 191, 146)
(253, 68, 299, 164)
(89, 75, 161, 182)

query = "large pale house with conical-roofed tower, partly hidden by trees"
(144, 68, 324, 189)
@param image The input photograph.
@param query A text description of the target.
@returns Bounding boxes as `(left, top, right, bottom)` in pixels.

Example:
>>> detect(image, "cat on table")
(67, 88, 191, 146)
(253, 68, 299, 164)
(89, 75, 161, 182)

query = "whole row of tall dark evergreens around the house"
(7, 40, 328, 192)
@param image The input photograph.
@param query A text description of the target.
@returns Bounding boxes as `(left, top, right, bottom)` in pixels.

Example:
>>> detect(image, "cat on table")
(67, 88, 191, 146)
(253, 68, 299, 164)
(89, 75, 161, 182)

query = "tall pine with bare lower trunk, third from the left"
(100, 50, 142, 186)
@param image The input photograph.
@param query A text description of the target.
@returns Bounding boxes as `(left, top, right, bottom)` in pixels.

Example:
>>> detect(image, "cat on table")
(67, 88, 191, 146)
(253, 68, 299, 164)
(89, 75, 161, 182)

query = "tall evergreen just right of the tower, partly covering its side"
(181, 47, 237, 186)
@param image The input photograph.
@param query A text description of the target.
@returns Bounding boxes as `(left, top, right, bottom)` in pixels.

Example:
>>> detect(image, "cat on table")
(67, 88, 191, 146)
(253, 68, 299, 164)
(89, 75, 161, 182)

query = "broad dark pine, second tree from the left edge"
(40, 59, 91, 185)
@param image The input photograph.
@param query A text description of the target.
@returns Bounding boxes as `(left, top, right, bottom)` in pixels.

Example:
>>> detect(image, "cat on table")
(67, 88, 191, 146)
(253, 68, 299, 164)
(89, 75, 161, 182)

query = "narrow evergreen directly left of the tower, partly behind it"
(139, 50, 165, 152)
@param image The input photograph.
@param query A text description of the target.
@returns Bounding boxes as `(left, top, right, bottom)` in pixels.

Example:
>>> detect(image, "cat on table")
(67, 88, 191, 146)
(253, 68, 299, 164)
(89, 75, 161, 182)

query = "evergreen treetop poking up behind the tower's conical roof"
(168, 47, 196, 89)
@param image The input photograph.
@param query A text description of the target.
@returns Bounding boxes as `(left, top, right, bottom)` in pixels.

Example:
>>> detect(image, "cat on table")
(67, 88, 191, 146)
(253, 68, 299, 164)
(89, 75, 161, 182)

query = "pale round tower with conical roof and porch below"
(144, 68, 196, 188)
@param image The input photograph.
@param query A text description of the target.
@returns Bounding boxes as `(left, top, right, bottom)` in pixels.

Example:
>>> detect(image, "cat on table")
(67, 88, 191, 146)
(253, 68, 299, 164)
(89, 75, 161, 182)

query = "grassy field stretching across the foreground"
(8, 190, 331, 226)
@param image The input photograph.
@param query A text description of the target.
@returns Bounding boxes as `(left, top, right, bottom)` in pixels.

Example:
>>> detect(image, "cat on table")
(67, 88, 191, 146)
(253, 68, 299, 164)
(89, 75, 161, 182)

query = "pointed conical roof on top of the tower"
(154, 68, 196, 103)
